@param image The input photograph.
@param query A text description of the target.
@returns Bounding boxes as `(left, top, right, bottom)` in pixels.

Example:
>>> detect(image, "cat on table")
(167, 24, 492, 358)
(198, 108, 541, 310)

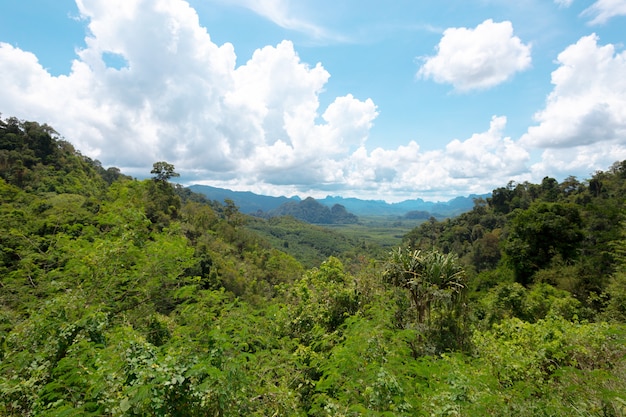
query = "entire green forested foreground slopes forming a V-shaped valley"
(0, 118, 626, 417)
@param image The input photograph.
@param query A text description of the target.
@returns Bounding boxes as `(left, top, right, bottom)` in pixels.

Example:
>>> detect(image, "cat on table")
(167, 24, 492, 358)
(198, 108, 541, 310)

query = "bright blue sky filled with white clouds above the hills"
(0, 0, 626, 202)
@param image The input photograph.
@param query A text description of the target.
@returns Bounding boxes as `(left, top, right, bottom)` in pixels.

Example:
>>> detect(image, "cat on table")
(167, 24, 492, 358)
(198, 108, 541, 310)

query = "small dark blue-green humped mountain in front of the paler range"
(266, 197, 359, 224)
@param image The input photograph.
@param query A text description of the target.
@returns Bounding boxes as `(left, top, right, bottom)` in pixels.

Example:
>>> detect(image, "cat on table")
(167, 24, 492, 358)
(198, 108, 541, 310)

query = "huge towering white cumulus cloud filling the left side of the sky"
(0, 0, 377, 182)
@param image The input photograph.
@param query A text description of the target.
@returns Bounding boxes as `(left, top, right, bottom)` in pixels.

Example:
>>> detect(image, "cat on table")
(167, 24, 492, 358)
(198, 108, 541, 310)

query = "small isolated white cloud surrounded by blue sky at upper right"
(418, 19, 531, 91)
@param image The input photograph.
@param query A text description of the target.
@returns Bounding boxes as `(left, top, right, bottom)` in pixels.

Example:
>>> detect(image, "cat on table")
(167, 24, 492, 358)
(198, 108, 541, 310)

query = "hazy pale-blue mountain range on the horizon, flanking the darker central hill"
(189, 185, 491, 218)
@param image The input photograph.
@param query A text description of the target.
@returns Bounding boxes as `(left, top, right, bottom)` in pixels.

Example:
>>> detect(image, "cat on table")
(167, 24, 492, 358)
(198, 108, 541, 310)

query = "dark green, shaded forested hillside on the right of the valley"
(404, 161, 626, 300)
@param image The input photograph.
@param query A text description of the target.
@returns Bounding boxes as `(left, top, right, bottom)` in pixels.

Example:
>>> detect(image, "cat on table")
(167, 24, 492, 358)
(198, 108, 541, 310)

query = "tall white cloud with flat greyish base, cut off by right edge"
(521, 35, 626, 148)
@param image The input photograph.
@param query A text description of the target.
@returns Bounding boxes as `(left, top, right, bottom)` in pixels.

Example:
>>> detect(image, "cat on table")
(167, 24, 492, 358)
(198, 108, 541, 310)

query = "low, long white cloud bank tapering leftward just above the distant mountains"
(195, 114, 532, 201)
